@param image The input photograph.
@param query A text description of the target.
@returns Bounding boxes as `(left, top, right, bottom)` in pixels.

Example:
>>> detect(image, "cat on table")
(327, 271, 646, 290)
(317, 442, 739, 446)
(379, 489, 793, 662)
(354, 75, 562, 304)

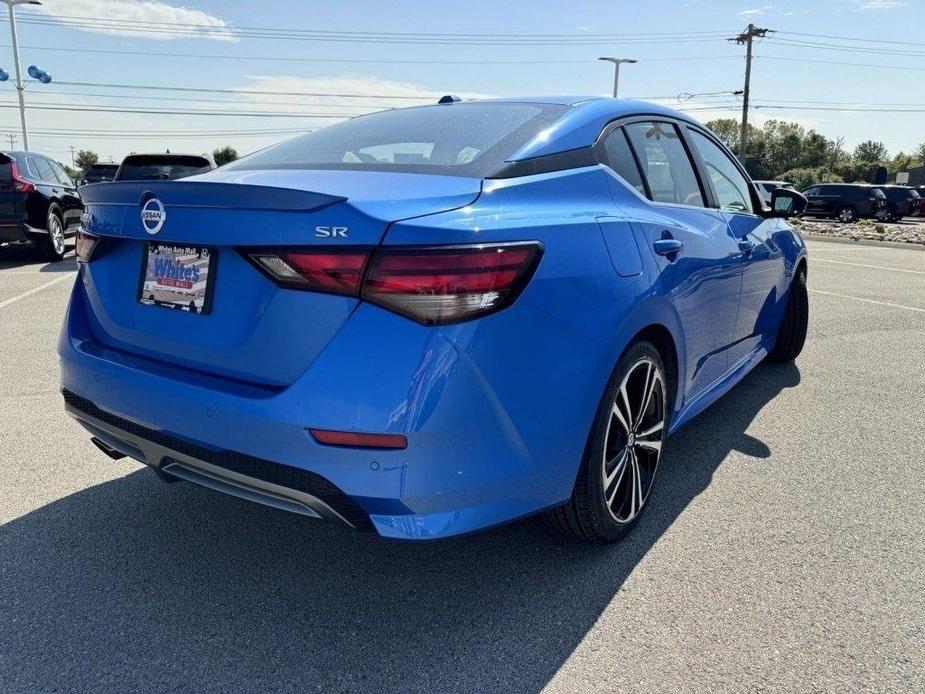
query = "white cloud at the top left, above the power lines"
(35, 0, 237, 41)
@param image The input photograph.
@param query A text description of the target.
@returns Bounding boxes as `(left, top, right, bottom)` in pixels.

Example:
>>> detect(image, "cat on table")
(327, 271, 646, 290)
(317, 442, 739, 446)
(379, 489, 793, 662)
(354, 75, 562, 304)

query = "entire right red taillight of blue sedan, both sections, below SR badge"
(242, 241, 542, 325)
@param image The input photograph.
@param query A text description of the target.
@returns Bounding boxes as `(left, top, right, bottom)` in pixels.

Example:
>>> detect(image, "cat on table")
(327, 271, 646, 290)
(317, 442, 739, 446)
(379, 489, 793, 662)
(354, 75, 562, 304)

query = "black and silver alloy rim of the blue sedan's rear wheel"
(602, 357, 666, 524)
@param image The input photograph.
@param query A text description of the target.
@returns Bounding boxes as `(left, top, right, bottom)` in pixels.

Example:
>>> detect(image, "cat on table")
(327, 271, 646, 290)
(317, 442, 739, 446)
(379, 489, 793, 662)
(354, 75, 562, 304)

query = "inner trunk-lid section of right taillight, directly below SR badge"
(246, 248, 369, 296)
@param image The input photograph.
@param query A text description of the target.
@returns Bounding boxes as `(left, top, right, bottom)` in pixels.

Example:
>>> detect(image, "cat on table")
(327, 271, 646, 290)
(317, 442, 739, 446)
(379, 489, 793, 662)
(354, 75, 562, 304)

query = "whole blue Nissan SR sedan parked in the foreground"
(58, 97, 808, 542)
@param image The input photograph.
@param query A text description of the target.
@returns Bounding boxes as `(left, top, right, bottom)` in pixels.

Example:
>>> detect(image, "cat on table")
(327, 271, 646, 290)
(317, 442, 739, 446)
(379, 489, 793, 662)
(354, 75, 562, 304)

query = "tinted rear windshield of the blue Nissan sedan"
(225, 103, 568, 178)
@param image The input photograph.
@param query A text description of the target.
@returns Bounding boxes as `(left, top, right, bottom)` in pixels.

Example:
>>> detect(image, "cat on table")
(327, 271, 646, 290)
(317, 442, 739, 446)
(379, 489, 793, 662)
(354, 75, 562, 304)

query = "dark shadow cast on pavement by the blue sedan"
(0, 364, 800, 694)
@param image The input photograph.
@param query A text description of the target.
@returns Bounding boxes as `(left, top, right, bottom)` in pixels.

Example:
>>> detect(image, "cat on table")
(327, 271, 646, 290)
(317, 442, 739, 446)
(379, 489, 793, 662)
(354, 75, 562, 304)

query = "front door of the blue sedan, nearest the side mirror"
(687, 127, 784, 367)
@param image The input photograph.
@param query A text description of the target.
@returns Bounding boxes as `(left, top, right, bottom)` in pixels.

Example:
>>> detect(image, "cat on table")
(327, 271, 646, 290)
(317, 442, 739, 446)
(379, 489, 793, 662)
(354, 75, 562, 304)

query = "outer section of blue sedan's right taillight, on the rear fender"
(362, 242, 541, 325)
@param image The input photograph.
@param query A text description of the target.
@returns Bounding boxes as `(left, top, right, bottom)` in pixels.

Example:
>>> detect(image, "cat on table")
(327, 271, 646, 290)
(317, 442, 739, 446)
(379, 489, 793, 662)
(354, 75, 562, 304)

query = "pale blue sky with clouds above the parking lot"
(0, 0, 925, 164)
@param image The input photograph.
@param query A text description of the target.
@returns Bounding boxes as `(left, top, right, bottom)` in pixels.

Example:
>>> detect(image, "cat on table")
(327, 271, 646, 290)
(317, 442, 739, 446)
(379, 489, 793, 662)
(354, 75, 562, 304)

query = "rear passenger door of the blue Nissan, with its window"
(603, 119, 740, 400)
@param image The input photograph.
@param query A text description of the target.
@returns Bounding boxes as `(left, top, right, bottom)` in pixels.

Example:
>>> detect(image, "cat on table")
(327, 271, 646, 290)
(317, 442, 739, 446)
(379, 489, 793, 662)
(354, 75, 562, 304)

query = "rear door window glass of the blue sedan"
(626, 121, 705, 207)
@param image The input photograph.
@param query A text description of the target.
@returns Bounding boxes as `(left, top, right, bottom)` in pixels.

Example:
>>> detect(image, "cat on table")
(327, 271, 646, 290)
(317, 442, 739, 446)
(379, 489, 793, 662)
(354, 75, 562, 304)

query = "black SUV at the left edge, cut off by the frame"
(0, 151, 83, 261)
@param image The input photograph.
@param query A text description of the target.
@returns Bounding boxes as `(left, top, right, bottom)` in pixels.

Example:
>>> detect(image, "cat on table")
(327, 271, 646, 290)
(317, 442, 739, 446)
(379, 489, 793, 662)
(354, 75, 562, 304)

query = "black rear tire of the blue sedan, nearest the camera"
(546, 342, 669, 543)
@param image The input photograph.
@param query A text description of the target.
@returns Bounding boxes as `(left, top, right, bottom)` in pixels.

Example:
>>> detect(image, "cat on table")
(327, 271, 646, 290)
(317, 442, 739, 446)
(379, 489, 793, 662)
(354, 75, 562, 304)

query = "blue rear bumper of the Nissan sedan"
(58, 276, 609, 540)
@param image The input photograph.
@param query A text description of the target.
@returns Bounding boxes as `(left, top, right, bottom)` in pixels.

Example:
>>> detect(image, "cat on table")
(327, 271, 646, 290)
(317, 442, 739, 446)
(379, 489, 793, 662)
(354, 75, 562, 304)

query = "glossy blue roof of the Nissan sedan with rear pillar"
(458, 95, 700, 161)
